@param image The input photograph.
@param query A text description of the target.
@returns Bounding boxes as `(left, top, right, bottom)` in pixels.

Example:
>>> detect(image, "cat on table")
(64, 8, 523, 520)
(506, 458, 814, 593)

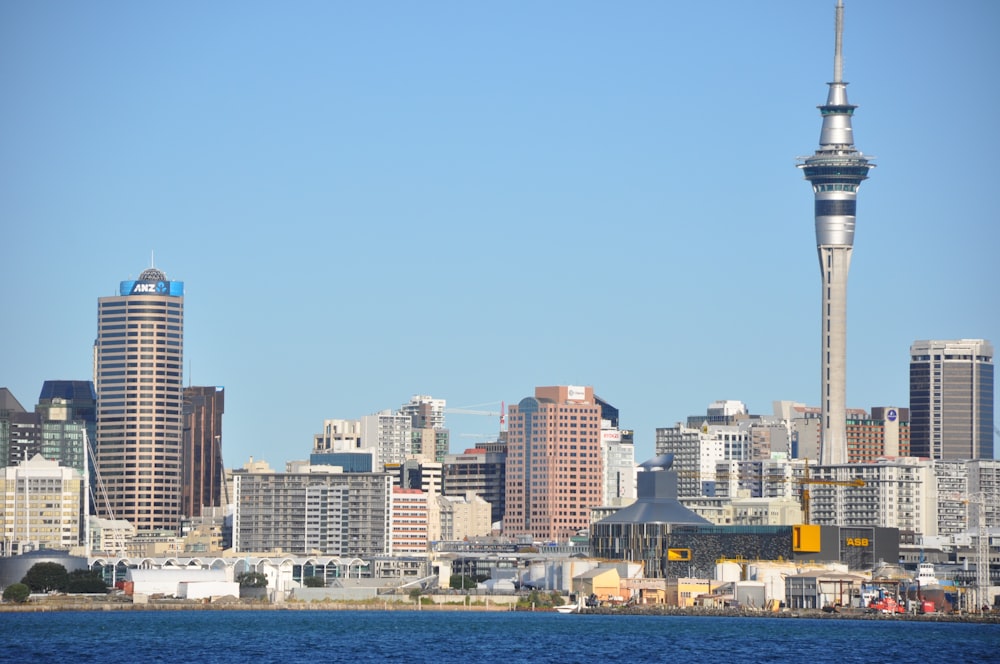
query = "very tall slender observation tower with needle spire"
(798, 0, 875, 464)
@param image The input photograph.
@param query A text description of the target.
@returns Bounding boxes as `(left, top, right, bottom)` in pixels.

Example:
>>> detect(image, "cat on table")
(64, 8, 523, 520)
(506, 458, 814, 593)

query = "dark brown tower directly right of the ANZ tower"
(181, 386, 229, 517)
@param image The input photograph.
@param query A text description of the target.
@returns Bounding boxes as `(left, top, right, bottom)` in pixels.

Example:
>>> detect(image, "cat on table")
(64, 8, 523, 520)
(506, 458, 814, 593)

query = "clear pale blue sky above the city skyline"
(0, 0, 1000, 468)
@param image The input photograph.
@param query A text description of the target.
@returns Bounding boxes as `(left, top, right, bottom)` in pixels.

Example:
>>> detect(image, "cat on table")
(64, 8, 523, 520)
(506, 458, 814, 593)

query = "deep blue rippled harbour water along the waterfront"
(0, 611, 1000, 664)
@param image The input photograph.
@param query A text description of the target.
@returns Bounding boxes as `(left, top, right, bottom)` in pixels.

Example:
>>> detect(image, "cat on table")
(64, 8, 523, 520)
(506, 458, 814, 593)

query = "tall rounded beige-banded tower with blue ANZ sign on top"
(94, 268, 184, 533)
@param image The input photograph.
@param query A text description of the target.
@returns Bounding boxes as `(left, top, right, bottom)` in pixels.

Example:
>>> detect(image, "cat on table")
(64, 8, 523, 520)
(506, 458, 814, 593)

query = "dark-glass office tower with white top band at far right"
(910, 339, 993, 459)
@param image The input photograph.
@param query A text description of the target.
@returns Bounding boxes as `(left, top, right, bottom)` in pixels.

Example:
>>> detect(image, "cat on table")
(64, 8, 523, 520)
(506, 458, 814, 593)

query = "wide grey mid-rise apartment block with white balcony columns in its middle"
(233, 464, 392, 558)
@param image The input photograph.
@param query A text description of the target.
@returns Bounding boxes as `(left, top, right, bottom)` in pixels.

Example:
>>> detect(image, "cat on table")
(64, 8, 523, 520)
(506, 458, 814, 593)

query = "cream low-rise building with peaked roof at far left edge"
(0, 454, 83, 556)
